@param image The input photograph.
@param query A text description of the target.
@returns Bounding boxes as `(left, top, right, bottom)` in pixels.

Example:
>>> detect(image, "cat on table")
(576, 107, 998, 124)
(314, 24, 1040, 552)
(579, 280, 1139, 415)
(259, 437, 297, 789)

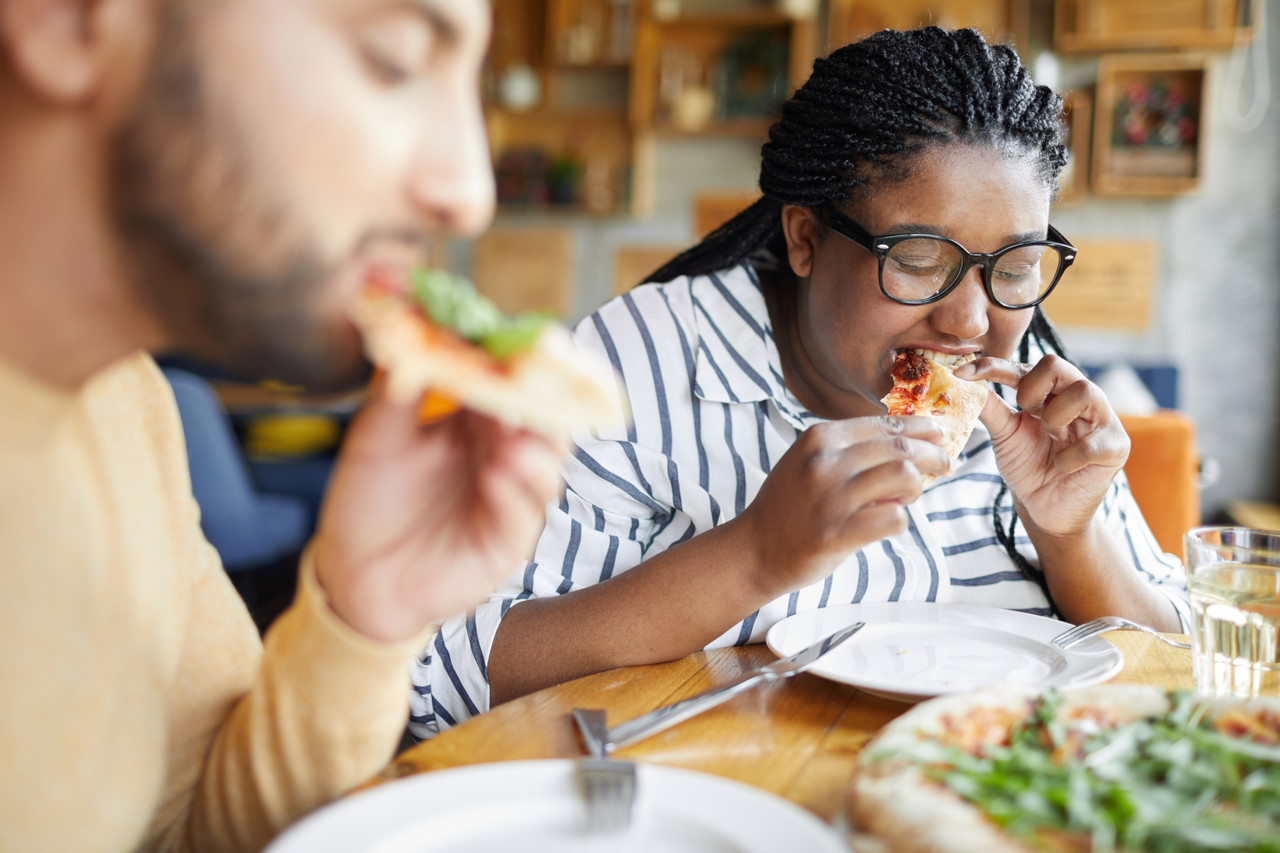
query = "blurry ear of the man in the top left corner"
(0, 0, 136, 102)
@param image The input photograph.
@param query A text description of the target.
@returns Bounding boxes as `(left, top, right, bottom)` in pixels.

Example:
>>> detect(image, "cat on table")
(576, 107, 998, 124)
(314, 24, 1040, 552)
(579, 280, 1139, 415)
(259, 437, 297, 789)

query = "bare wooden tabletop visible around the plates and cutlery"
(381, 631, 1192, 821)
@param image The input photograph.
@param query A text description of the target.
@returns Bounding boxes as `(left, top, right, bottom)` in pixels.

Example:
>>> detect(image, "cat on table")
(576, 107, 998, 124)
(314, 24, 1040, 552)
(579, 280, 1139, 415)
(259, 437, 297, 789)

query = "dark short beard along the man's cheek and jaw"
(111, 3, 369, 391)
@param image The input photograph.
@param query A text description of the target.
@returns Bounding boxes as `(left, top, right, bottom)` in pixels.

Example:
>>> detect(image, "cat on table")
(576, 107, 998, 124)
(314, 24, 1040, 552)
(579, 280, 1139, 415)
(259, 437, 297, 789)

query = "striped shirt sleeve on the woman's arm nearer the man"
(410, 288, 707, 738)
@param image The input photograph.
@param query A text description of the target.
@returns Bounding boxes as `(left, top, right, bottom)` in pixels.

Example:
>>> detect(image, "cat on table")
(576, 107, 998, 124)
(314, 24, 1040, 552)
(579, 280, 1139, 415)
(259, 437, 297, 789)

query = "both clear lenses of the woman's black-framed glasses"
(881, 237, 1062, 306)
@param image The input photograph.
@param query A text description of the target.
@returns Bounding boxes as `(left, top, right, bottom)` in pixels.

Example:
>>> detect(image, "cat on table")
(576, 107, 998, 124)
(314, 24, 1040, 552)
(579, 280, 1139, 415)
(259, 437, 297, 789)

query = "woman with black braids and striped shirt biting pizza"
(413, 28, 1187, 735)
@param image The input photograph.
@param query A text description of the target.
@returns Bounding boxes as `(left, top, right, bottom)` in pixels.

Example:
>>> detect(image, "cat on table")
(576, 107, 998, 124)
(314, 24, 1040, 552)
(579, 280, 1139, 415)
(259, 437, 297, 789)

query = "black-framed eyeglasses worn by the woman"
(817, 207, 1075, 309)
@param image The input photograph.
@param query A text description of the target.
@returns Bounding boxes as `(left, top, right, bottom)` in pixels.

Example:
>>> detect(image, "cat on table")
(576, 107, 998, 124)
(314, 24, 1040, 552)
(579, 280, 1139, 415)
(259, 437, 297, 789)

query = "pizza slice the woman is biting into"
(881, 350, 987, 485)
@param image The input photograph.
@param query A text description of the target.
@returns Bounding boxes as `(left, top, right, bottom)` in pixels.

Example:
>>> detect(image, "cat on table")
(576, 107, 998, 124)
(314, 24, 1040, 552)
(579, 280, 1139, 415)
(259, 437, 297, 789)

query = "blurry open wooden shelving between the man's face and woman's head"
(484, 0, 817, 214)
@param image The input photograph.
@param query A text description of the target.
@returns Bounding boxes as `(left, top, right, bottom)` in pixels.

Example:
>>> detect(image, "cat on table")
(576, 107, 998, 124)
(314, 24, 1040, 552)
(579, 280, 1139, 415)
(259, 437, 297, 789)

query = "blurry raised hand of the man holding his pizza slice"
(314, 383, 563, 642)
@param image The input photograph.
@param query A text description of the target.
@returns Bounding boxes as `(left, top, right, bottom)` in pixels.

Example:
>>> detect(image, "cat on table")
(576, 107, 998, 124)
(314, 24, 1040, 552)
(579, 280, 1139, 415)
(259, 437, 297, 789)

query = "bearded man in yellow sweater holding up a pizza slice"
(0, 0, 559, 850)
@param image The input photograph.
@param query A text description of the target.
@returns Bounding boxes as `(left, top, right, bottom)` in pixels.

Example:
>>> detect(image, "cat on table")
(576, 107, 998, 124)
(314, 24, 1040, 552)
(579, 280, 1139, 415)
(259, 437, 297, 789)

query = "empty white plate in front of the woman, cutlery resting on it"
(764, 602, 1124, 702)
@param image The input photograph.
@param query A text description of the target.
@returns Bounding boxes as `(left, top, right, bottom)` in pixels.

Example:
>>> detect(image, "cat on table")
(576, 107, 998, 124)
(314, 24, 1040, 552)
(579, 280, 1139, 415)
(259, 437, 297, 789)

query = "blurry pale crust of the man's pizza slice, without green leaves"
(352, 291, 630, 439)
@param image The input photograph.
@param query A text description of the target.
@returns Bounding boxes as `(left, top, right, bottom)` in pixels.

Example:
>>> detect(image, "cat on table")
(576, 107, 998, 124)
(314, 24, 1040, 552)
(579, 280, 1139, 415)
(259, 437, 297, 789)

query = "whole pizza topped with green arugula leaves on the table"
(850, 685, 1280, 853)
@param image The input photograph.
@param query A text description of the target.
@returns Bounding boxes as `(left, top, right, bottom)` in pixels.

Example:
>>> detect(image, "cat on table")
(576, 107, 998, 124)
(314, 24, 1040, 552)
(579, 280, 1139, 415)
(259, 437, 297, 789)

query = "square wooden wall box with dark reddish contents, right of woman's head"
(1092, 54, 1206, 196)
